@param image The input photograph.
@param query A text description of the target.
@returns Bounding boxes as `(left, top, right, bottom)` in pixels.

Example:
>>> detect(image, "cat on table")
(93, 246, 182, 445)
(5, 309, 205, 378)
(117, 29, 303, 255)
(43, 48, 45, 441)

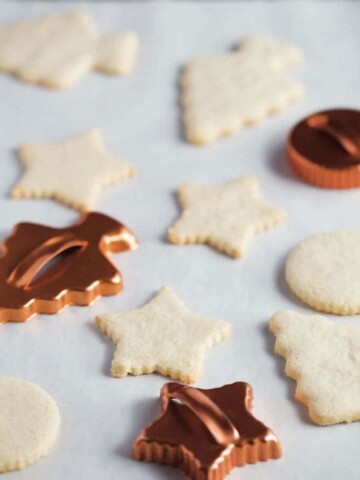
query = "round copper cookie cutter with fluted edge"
(287, 109, 360, 188)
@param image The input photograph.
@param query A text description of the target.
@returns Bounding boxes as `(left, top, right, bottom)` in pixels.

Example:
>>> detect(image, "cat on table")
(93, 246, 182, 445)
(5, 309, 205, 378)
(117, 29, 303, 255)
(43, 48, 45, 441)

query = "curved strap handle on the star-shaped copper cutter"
(161, 382, 240, 446)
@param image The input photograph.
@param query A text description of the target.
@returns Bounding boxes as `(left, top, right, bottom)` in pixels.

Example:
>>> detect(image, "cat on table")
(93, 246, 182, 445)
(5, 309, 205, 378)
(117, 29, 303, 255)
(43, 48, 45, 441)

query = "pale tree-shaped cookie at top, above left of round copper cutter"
(181, 37, 302, 145)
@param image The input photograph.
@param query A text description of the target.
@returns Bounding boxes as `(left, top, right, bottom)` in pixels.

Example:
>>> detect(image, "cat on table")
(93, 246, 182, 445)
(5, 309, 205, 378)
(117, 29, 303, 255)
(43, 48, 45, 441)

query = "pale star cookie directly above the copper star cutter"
(96, 287, 231, 383)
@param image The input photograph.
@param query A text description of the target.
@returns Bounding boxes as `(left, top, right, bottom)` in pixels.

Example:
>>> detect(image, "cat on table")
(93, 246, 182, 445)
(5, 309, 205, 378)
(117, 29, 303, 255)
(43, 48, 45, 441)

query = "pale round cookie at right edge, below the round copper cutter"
(285, 230, 360, 315)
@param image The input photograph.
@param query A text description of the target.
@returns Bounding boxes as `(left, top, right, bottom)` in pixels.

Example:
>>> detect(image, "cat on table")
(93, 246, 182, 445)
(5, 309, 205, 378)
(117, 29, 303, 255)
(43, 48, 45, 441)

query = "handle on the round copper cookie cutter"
(308, 113, 360, 163)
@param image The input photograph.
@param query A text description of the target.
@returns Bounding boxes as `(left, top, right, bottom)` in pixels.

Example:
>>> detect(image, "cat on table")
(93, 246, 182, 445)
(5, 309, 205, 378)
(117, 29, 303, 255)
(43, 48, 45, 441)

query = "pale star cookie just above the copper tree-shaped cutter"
(12, 129, 135, 211)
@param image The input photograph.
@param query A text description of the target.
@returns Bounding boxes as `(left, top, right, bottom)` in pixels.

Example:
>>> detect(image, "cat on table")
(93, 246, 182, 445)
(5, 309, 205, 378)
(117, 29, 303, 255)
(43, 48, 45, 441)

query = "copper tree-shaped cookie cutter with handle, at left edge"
(0, 212, 137, 323)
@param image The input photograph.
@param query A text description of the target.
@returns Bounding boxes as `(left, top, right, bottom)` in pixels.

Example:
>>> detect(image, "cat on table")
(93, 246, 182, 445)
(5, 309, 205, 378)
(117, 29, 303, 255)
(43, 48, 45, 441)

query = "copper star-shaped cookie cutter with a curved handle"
(133, 382, 281, 480)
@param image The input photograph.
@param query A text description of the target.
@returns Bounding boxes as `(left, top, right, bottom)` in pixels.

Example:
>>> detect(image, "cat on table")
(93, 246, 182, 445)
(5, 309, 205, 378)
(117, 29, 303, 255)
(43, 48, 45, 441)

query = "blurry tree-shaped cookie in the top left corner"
(0, 12, 139, 88)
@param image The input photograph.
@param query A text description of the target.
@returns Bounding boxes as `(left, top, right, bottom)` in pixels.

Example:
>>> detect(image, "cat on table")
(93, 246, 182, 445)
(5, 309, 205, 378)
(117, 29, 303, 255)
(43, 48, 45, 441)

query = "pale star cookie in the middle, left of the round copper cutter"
(168, 176, 286, 258)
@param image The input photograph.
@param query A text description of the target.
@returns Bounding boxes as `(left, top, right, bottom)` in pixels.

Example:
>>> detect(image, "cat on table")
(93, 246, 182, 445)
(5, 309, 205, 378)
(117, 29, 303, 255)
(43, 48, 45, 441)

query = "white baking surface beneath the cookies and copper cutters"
(0, 1, 360, 480)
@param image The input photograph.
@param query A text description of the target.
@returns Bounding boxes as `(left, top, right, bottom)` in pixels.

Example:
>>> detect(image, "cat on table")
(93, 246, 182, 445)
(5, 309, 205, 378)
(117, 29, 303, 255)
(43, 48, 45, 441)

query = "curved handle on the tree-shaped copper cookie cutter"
(7, 234, 88, 288)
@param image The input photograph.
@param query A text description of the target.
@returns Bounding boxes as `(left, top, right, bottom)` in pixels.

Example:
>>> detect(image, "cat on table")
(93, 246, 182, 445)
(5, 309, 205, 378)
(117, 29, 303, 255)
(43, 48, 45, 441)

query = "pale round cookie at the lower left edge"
(0, 377, 60, 472)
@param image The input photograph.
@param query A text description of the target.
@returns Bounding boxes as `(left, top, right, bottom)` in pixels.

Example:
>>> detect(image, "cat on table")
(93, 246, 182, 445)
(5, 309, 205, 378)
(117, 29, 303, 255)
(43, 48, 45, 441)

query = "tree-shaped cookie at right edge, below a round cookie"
(269, 311, 360, 425)
